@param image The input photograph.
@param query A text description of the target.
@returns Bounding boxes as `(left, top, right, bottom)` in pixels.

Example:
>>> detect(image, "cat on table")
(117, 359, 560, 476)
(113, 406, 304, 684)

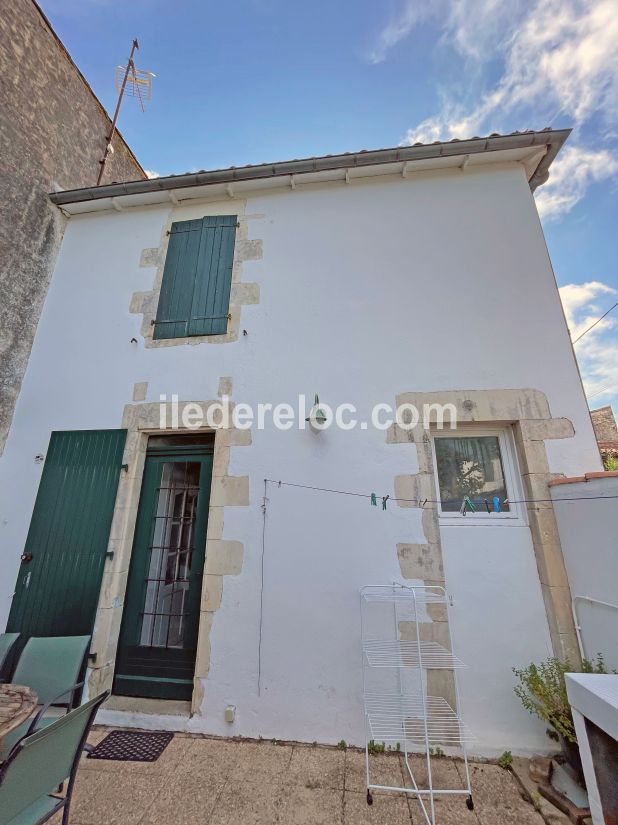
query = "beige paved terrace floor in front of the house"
(51, 728, 544, 825)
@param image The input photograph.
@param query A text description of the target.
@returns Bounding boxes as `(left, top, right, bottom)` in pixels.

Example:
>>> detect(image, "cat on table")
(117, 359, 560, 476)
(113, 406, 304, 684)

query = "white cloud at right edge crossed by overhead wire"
(560, 281, 618, 407)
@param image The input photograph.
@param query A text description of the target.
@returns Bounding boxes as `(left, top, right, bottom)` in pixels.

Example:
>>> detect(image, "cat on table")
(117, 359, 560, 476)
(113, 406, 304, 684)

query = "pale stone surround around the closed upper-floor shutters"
(129, 199, 262, 348)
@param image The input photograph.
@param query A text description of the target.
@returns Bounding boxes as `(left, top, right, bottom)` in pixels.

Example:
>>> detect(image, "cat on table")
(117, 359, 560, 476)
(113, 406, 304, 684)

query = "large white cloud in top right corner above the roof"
(394, 0, 618, 132)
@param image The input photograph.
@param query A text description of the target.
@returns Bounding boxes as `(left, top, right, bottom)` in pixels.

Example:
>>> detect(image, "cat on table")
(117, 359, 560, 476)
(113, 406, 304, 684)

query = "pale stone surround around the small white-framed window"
(386, 389, 580, 706)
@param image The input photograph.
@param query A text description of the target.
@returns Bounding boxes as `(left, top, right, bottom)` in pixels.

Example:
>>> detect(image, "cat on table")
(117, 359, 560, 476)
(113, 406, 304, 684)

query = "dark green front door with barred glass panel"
(114, 436, 212, 699)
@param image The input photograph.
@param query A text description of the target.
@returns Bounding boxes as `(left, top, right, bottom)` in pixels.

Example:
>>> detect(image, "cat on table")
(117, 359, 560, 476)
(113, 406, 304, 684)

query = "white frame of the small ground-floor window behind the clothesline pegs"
(431, 425, 526, 527)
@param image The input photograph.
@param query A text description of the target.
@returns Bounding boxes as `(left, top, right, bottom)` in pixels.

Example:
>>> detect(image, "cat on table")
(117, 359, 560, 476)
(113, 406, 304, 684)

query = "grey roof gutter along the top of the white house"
(49, 129, 571, 206)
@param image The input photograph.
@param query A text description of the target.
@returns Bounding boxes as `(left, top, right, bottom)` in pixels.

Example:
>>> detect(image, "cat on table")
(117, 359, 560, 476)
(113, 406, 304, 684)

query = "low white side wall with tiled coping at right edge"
(551, 475, 618, 669)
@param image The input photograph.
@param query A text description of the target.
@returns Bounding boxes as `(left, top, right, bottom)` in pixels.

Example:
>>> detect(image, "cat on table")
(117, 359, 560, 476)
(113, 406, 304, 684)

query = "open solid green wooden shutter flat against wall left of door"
(7, 430, 127, 645)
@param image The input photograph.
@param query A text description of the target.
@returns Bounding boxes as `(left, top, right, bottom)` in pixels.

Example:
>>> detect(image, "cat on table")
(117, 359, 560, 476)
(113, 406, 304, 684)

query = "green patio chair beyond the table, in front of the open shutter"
(0, 636, 90, 761)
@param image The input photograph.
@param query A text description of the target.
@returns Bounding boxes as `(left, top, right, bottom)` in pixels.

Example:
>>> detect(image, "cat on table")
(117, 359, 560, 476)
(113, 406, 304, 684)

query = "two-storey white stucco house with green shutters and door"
(0, 130, 601, 754)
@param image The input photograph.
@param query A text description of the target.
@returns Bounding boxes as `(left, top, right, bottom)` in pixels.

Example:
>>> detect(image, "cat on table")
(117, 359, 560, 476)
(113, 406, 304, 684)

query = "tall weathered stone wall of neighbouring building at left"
(0, 0, 145, 454)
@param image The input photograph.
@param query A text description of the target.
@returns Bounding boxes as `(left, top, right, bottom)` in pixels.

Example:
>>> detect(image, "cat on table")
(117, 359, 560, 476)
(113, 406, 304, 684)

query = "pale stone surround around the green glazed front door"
(87, 390, 251, 714)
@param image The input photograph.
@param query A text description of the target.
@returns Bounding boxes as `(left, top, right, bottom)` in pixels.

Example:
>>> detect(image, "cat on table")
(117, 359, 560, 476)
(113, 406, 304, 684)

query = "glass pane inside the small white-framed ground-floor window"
(434, 435, 510, 513)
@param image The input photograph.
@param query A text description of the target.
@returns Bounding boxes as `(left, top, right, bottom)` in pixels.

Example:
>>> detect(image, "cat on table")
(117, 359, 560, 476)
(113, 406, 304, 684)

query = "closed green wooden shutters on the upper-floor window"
(154, 215, 238, 338)
